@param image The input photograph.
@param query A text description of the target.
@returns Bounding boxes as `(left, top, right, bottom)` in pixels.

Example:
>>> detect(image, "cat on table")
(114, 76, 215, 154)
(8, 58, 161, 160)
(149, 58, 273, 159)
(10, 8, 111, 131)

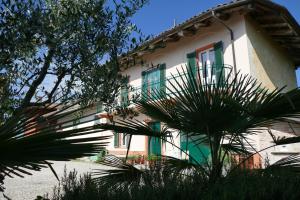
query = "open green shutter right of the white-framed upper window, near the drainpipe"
(214, 41, 225, 83)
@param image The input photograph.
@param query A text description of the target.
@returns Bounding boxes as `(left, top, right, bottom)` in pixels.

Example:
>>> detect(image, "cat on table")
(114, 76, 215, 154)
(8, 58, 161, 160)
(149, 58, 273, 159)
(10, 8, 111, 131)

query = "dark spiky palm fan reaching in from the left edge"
(0, 102, 110, 192)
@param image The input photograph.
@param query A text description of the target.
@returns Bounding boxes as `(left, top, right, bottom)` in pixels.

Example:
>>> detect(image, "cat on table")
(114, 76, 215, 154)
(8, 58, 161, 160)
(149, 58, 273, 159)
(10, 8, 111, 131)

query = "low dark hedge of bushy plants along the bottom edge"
(44, 166, 300, 200)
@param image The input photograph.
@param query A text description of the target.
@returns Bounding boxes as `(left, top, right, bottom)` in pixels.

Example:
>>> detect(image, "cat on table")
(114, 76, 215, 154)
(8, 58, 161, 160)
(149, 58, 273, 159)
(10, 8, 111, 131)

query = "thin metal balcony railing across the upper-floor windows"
(120, 65, 233, 106)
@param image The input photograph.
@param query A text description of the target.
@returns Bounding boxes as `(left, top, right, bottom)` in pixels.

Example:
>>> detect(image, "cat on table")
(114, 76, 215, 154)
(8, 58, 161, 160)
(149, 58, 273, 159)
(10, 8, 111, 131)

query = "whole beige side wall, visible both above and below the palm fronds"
(245, 17, 300, 166)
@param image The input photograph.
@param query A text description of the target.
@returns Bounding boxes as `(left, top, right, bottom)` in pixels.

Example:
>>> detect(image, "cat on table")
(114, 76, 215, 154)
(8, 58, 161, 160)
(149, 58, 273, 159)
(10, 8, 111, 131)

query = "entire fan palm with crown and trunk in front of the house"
(98, 65, 300, 183)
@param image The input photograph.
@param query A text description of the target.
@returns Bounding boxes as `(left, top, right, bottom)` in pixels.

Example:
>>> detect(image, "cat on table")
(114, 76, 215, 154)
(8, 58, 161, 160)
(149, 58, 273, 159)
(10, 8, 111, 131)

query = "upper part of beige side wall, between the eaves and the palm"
(245, 17, 297, 90)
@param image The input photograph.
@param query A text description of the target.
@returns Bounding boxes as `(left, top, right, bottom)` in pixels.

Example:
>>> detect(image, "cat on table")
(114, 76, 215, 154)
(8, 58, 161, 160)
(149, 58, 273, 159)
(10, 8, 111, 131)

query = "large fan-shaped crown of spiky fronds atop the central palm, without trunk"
(136, 69, 300, 138)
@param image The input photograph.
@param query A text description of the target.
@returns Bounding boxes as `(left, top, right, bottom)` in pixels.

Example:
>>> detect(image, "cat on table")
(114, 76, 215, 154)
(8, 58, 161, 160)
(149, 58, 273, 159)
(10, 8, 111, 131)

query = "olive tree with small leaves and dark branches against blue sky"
(0, 0, 146, 118)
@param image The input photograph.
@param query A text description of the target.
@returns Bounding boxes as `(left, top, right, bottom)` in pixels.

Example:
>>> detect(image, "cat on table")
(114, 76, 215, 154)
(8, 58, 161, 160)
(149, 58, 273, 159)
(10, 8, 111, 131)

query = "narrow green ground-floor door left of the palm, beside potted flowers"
(148, 122, 161, 156)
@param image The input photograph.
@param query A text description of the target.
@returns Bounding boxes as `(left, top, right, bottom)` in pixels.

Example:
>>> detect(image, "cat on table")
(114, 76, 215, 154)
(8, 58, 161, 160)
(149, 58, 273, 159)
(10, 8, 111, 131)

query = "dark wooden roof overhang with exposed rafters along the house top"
(121, 0, 300, 66)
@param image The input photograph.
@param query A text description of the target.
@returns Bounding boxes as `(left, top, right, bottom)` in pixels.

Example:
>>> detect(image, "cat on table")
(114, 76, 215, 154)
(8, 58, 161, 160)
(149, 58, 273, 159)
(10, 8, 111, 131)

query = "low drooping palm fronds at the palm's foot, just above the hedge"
(92, 155, 207, 191)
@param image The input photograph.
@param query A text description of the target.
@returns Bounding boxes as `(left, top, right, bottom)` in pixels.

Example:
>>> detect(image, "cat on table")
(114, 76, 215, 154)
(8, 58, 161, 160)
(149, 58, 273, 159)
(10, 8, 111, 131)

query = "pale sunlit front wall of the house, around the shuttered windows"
(118, 12, 250, 158)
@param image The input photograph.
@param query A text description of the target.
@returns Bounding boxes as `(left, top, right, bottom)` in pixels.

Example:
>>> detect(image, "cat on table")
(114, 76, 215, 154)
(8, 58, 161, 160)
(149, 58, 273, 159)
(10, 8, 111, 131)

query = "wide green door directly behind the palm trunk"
(180, 134, 210, 164)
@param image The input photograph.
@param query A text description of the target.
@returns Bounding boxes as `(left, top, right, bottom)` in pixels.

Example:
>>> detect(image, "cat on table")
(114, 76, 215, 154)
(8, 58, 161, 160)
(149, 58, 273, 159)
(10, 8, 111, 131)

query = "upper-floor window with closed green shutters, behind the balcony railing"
(142, 64, 166, 100)
